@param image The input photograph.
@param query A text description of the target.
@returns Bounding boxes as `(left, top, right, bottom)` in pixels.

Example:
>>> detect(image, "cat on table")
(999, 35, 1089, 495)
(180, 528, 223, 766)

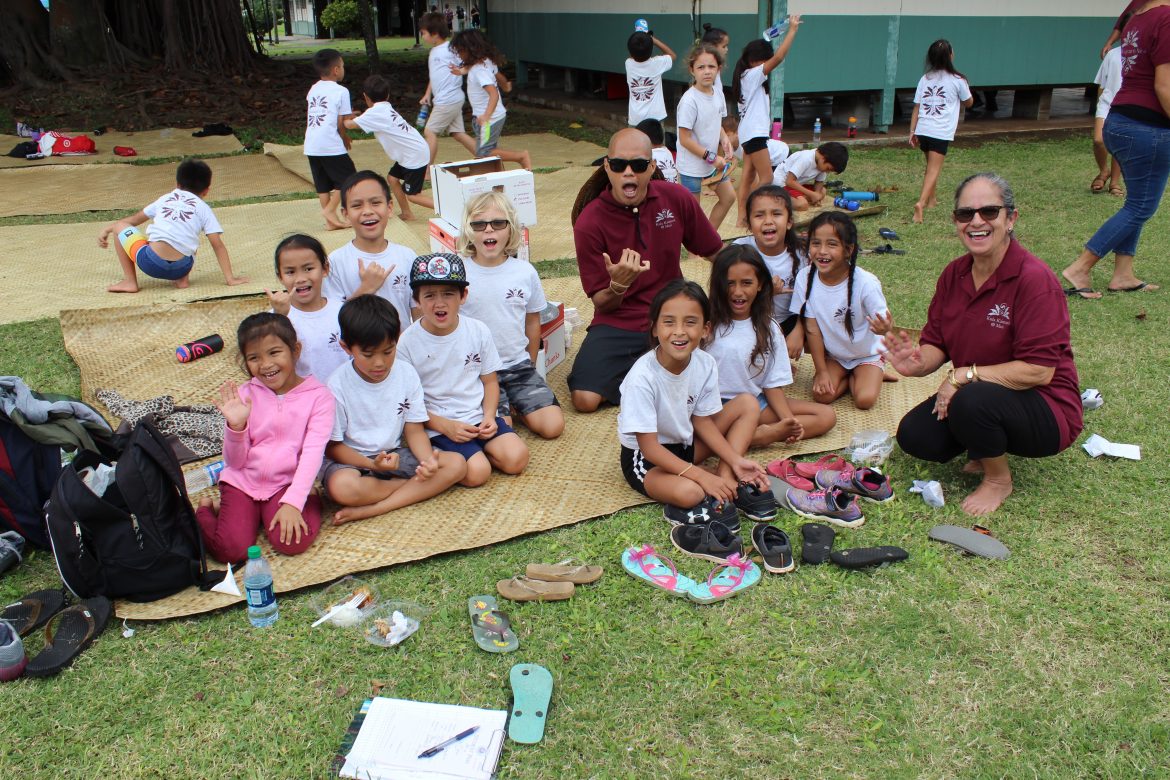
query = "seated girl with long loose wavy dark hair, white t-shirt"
(703, 244, 837, 447)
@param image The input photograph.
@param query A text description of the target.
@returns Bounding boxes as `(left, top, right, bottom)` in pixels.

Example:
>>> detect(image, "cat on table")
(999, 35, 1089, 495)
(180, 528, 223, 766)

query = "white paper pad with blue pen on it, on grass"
(338, 697, 508, 780)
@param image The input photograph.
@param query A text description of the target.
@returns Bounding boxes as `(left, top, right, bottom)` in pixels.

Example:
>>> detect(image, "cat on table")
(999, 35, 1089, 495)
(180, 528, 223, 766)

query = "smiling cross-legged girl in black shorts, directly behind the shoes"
(618, 278, 776, 529)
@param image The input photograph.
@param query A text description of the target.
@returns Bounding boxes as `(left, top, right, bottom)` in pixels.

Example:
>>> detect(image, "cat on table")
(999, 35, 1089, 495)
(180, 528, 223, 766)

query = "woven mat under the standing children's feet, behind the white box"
(264, 133, 605, 181)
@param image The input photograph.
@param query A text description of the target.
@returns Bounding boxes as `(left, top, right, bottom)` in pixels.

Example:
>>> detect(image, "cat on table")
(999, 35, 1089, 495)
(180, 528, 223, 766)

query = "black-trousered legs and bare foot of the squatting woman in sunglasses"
(897, 382, 1060, 516)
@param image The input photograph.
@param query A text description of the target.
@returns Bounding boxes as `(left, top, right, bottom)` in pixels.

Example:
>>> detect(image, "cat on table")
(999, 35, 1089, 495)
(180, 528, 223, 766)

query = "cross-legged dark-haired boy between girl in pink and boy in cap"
(324, 295, 467, 525)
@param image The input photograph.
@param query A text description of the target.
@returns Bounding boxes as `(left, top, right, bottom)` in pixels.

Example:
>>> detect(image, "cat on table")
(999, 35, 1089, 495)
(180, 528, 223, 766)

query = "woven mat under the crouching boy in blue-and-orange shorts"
(0, 198, 427, 327)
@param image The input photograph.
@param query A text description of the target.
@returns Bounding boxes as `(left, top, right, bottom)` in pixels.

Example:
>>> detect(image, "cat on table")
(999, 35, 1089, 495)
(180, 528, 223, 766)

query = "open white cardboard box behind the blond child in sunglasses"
(431, 157, 536, 226)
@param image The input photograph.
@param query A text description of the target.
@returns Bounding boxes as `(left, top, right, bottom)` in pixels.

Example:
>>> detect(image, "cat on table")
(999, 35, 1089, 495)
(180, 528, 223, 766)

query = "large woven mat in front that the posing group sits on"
(61, 261, 938, 620)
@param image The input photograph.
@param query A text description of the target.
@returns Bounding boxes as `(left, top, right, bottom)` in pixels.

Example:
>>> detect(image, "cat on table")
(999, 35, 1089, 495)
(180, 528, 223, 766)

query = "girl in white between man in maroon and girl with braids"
(735, 185, 808, 360)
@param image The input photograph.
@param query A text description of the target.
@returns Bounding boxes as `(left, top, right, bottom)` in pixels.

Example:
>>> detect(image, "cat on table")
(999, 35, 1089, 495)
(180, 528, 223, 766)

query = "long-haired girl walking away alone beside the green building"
(910, 39, 975, 222)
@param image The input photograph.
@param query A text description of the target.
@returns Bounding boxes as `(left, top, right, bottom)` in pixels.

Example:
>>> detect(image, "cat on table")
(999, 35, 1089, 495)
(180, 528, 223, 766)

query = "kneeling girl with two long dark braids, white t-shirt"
(792, 212, 889, 409)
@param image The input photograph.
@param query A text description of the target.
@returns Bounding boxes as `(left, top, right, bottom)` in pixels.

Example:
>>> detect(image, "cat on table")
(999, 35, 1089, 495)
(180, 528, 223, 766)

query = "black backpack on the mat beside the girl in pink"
(44, 416, 223, 601)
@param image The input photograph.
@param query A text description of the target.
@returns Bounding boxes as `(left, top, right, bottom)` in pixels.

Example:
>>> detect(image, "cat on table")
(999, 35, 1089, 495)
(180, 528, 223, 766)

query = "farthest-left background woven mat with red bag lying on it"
(0, 127, 243, 168)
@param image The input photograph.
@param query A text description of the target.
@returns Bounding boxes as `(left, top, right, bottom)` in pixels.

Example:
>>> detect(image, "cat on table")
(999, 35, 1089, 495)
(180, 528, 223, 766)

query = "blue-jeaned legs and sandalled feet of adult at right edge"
(1061, 112, 1170, 298)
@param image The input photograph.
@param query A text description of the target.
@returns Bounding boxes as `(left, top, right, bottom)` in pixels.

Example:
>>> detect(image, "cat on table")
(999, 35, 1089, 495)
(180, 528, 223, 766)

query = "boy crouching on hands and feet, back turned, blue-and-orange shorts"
(97, 159, 248, 292)
